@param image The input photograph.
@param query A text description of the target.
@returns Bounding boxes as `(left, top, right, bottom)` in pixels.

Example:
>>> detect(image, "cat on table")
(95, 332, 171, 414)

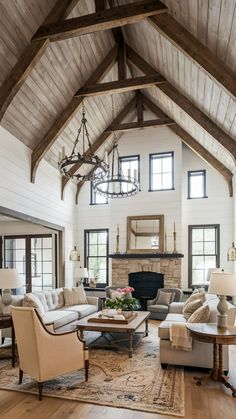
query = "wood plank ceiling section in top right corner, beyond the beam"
(162, 0, 236, 71)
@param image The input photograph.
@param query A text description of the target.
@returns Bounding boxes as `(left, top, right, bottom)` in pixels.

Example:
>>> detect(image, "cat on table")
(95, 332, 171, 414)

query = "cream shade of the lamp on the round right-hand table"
(208, 272, 236, 296)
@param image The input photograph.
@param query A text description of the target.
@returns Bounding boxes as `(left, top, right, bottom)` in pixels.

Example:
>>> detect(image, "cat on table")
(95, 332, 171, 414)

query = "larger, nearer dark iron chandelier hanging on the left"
(58, 104, 108, 180)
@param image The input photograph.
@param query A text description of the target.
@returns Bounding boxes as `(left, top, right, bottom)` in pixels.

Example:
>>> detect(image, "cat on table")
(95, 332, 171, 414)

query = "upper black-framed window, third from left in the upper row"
(149, 151, 174, 192)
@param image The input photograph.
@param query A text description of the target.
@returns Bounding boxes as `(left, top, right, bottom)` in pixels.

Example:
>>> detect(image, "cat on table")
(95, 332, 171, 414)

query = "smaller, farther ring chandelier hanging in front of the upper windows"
(93, 142, 139, 198)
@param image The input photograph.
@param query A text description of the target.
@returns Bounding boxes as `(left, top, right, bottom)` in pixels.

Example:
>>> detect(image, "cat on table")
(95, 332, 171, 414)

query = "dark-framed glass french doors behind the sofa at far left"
(4, 234, 57, 293)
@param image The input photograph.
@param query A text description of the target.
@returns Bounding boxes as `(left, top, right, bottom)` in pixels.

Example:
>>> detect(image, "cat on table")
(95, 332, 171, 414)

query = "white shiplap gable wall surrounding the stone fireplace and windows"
(78, 123, 234, 288)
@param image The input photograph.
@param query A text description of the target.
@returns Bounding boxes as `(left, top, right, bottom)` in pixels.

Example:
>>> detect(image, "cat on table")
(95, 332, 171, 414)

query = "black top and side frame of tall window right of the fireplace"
(188, 224, 220, 288)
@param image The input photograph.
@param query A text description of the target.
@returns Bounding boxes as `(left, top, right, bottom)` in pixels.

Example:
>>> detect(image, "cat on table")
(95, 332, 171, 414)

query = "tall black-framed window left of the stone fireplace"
(84, 229, 109, 287)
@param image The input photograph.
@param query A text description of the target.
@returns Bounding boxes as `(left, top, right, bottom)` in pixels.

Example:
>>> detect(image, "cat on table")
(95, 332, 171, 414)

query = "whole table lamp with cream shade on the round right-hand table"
(208, 272, 236, 327)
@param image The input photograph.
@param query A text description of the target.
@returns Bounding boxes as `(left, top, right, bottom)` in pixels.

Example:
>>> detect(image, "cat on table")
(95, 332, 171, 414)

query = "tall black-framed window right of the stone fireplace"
(189, 224, 220, 287)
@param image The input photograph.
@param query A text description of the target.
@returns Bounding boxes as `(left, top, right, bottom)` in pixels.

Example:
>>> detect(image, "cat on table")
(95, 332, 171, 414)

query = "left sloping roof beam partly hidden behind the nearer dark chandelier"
(61, 97, 136, 199)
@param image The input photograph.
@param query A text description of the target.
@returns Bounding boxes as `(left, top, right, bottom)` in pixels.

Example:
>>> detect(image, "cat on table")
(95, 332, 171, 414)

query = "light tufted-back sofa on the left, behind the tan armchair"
(0, 288, 99, 337)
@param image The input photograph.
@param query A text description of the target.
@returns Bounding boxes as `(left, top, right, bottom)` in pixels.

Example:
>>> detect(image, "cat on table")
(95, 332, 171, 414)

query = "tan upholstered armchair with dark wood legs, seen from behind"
(11, 307, 89, 400)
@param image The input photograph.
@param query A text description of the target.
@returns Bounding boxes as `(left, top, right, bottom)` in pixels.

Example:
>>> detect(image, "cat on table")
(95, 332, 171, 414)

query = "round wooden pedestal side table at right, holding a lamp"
(187, 323, 236, 397)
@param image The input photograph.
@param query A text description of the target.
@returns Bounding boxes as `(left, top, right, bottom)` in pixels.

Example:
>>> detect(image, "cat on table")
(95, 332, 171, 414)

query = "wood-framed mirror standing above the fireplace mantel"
(127, 215, 164, 253)
